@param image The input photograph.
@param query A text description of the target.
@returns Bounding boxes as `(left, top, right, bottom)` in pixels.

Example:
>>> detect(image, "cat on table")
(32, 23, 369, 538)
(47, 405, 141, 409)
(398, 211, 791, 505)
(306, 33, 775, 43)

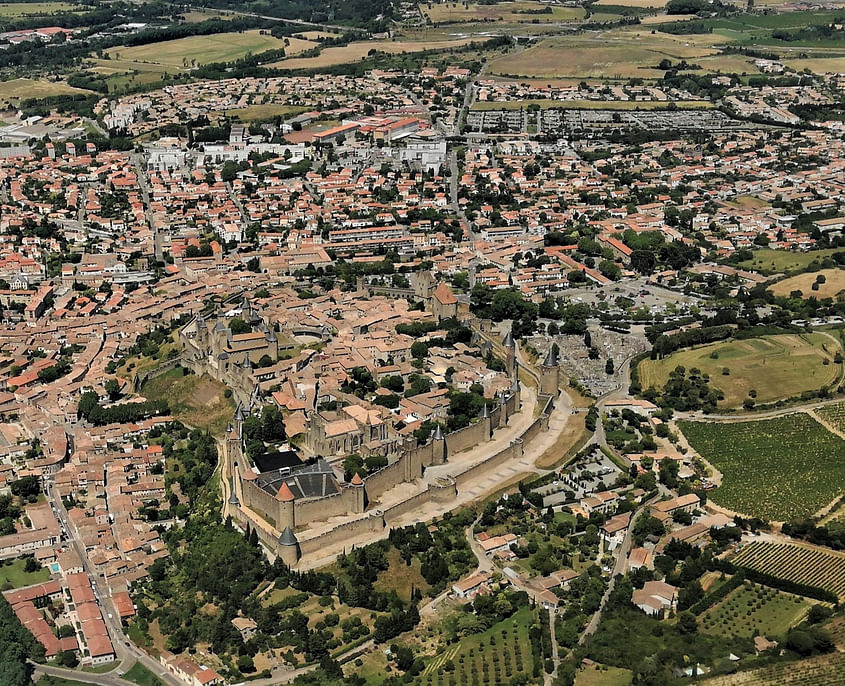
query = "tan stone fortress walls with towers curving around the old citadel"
(176, 292, 559, 566)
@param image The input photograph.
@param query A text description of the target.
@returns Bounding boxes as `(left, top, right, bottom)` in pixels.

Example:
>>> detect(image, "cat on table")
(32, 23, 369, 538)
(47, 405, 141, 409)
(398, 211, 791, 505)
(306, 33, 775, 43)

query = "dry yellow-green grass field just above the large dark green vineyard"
(637, 333, 842, 407)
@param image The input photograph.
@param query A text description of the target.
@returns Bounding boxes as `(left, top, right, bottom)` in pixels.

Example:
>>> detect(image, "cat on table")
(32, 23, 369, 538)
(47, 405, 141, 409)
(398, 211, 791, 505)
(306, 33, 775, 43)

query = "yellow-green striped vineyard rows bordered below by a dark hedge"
(731, 542, 845, 602)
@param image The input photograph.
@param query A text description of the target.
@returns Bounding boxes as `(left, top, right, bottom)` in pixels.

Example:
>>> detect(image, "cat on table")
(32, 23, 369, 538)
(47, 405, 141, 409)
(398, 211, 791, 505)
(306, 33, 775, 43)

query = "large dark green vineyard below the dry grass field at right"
(679, 413, 845, 521)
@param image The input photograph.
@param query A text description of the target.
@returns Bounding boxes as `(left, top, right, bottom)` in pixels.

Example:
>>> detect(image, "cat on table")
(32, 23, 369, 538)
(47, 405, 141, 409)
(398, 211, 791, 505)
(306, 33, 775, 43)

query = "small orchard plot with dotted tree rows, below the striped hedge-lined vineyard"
(699, 582, 812, 638)
